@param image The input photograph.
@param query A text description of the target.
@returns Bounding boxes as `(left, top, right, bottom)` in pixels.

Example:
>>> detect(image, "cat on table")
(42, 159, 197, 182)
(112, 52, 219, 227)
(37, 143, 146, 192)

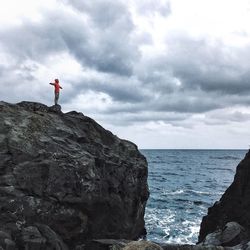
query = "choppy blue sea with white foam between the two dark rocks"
(141, 150, 247, 244)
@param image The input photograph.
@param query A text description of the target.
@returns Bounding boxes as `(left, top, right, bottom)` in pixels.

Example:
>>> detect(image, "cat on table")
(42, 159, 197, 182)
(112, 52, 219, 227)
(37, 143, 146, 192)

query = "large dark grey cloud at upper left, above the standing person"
(0, 1, 140, 75)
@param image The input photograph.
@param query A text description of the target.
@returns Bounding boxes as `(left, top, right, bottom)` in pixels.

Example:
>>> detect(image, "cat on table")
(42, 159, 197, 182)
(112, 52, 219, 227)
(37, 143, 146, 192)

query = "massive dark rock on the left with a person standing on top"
(0, 102, 149, 249)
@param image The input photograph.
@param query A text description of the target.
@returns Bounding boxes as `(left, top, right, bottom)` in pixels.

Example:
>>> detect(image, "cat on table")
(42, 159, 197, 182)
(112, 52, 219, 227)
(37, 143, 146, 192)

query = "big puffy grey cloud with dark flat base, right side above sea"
(138, 34, 250, 98)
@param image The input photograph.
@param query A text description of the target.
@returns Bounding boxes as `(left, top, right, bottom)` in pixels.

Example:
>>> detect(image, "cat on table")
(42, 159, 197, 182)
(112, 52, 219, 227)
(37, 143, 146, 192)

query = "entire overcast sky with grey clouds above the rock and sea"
(0, 0, 250, 149)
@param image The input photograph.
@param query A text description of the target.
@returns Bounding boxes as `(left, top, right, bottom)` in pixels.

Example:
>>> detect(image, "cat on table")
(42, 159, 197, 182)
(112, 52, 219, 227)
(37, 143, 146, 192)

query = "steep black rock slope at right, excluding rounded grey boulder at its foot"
(199, 152, 250, 245)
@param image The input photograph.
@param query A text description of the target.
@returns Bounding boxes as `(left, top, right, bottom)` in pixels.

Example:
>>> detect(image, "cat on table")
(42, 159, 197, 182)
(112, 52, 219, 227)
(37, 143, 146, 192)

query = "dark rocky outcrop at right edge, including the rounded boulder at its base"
(199, 152, 250, 246)
